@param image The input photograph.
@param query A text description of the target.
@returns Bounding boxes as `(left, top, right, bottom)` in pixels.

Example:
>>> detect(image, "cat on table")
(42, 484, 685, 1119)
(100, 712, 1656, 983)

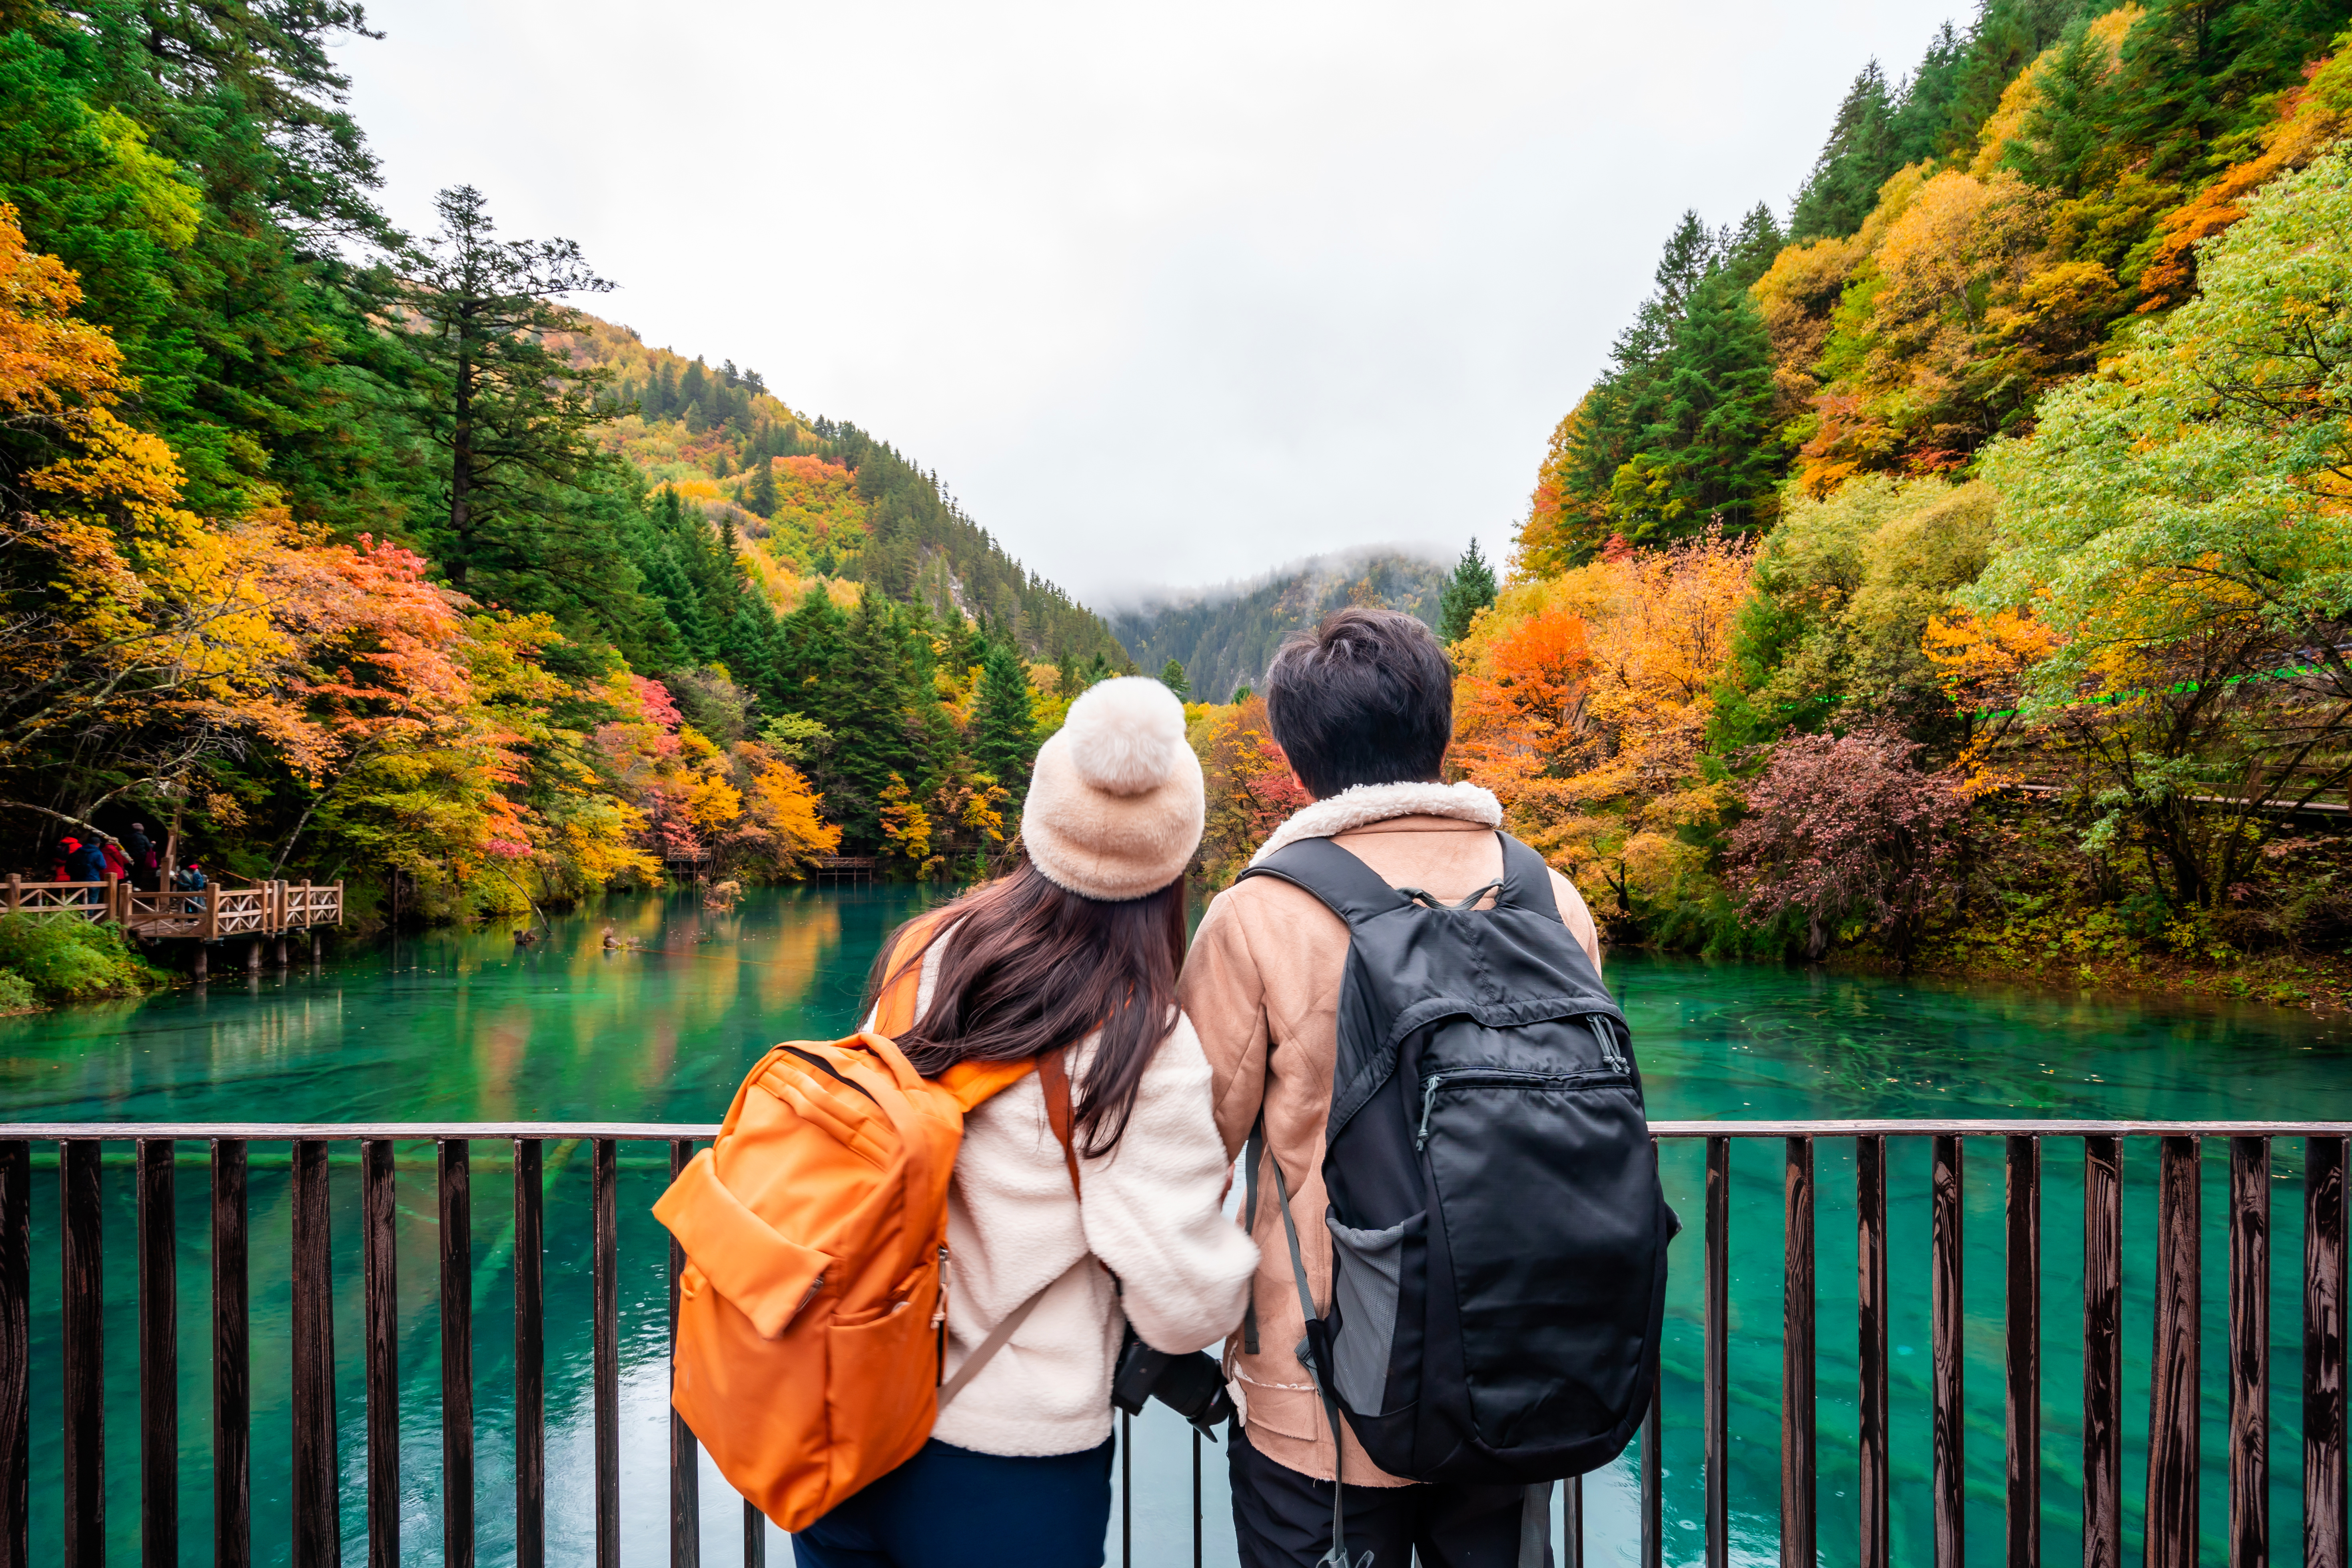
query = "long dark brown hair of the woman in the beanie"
(866, 858, 1186, 1154)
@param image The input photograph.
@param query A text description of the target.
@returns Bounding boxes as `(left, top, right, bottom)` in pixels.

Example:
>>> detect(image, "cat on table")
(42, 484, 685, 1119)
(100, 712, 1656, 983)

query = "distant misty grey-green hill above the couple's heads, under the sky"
(1110, 552, 1446, 703)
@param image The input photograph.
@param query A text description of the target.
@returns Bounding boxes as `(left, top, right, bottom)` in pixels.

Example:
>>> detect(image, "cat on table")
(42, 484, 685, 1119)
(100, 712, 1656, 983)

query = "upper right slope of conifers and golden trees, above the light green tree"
(1522, 0, 2352, 567)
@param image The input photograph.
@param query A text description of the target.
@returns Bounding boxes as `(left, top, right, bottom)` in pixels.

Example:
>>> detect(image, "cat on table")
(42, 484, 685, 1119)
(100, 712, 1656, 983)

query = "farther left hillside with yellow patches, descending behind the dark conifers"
(565, 320, 1122, 663)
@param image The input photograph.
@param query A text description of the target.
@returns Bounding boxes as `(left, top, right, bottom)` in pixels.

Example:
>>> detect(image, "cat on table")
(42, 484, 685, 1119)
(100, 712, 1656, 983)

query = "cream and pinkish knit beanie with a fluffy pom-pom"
(1021, 675, 1206, 903)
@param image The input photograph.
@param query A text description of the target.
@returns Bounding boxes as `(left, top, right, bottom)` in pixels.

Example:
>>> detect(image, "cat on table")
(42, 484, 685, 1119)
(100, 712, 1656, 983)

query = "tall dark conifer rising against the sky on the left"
(402, 186, 611, 588)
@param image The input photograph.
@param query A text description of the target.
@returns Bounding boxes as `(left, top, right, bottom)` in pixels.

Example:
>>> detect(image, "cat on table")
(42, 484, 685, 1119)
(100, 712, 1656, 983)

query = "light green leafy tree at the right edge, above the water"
(1962, 153, 2352, 907)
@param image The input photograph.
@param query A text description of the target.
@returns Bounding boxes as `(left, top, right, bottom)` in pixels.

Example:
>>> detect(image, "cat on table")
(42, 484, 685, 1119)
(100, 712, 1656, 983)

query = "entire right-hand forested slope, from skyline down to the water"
(1454, 0, 2352, 1001)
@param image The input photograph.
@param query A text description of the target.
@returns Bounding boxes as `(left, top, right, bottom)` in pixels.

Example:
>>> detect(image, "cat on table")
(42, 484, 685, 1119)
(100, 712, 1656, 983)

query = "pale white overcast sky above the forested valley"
(327, 0, 1964, 607)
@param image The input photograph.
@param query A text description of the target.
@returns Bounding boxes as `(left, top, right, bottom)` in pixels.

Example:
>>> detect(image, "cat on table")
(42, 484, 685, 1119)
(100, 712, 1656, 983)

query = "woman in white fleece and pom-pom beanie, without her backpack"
(793, 677, 1258, 1568)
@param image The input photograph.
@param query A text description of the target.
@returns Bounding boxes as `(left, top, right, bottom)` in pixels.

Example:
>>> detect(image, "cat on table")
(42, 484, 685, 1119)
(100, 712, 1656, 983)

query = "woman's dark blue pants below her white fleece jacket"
(793, 1439, 1112, 1568)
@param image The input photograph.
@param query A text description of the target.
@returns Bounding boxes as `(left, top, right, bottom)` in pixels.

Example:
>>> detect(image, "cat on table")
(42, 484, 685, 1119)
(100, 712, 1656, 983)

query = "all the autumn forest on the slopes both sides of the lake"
(0, 0, 2352, 1009)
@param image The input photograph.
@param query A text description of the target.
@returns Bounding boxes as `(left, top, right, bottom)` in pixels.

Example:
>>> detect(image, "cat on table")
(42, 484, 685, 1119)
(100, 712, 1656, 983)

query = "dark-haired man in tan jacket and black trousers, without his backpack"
(1178, 609, 1599, 1568)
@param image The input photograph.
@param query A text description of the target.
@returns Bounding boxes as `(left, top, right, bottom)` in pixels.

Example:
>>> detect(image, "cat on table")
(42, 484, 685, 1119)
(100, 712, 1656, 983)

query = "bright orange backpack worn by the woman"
(654, 926, 1077, 1530)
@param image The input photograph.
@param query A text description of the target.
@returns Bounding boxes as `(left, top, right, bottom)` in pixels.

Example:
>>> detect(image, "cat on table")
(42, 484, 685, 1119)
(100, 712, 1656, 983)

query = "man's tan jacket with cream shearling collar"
(1178, 783, 1602, 1486)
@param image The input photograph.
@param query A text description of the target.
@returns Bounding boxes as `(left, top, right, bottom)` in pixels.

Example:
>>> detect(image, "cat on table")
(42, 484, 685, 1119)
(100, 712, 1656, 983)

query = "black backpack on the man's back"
(1244, 835, 1679, 1495)
